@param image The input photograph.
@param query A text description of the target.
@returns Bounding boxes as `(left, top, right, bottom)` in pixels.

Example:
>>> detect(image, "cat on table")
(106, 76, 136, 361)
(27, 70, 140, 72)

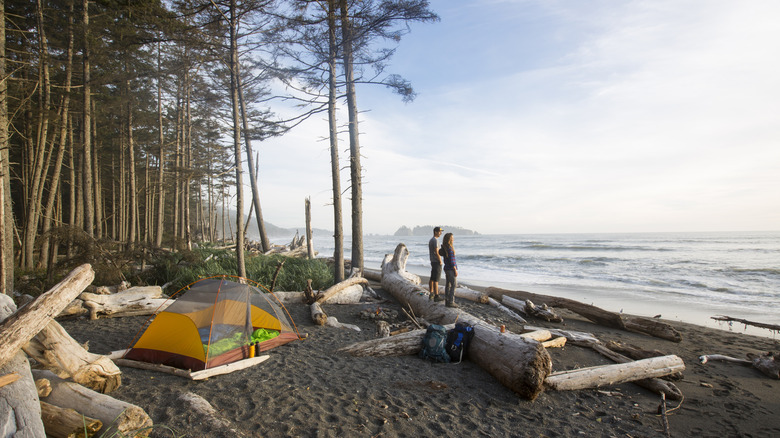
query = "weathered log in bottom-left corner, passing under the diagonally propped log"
(0, 293, 46, 437)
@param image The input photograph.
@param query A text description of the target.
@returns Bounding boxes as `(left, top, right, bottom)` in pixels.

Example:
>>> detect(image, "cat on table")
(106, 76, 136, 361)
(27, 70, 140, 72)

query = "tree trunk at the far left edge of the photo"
(0, 0, 14, 295)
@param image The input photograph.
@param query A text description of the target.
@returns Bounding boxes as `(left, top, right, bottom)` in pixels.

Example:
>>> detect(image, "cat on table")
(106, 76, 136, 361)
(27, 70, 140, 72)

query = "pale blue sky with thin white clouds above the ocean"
(256, 0, 780, 236)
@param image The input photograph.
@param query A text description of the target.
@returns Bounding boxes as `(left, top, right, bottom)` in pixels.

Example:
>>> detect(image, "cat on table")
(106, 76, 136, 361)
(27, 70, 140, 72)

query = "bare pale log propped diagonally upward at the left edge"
(0, 264, 95, 366)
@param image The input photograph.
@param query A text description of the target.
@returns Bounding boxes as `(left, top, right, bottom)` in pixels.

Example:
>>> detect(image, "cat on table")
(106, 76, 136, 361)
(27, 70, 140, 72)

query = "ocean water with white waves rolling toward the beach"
(302, 231, 780, 335)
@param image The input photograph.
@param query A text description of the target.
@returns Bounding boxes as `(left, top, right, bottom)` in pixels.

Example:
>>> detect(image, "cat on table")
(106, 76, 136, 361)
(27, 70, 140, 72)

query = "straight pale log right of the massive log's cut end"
(544, 355, 685, 391)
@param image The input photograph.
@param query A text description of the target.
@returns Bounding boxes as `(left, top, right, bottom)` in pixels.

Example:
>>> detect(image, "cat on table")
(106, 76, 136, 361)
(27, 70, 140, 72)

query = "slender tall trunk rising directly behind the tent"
(229, 0, 244, 278)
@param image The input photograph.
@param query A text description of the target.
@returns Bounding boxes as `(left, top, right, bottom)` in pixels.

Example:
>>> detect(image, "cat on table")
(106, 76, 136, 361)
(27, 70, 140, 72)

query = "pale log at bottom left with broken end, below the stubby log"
(33, 370, 153, 436)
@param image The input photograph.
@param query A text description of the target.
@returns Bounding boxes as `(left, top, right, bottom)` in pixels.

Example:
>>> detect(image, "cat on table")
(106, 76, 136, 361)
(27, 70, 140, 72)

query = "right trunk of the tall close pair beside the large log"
(341, 0, 363, 271)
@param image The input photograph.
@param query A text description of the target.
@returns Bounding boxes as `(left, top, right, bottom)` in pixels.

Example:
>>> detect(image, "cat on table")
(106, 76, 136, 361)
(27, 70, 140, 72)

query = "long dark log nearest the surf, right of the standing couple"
(486, 287, 682, 342)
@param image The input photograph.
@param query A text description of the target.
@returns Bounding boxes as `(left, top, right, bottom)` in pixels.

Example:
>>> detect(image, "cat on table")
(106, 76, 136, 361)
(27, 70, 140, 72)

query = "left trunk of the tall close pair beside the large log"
(328, 0, 344, 283)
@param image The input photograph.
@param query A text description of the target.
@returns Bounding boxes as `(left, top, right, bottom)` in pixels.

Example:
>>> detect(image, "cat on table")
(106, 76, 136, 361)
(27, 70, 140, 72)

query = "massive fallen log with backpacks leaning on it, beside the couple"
(382, 244, 552, 400)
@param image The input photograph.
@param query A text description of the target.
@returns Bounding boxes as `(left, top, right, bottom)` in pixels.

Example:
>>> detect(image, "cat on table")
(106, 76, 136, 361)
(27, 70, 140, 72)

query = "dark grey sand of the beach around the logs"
(61, 285, 780, 437)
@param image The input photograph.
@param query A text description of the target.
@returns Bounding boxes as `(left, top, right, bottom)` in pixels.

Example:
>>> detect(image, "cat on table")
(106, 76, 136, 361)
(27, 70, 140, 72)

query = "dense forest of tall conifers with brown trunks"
(0, 0, 438, 294)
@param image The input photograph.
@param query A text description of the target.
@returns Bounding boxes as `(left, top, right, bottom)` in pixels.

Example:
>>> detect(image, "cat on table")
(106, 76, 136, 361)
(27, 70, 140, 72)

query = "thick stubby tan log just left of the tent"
(24, 321, 122, 394)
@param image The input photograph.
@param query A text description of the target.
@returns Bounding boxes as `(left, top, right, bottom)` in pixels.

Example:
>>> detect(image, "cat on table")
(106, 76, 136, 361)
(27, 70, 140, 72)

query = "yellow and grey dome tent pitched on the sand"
(124, 278, 298, 371)
